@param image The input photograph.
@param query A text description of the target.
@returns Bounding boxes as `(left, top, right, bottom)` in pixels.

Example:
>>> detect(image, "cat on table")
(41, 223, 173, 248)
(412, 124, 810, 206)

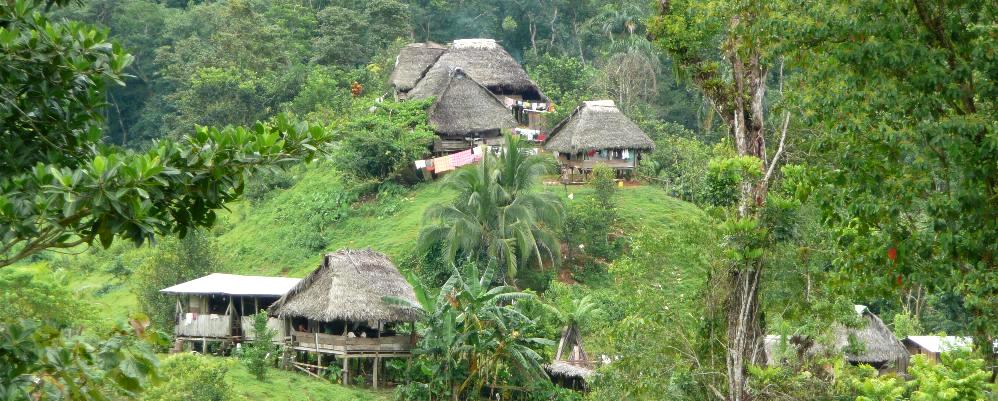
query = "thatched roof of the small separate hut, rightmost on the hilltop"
(544, 100, 655, 153)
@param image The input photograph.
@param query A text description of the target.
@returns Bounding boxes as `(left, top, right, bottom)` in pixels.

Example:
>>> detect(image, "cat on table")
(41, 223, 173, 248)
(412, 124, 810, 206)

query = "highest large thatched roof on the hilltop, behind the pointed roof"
(409, 39, 544, 100)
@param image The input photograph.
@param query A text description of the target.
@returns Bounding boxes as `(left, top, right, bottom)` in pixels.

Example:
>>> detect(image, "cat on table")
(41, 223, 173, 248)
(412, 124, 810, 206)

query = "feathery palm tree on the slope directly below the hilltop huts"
(419, 136, 564, 280)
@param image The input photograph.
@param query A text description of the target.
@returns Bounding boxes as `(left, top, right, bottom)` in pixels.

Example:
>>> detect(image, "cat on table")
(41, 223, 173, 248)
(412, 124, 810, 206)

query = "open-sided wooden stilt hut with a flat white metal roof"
(160, 273, 301, 351)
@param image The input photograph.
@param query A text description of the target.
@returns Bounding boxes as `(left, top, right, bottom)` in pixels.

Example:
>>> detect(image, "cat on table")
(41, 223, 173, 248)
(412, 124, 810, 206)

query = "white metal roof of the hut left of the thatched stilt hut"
(159, 273, 301, 297)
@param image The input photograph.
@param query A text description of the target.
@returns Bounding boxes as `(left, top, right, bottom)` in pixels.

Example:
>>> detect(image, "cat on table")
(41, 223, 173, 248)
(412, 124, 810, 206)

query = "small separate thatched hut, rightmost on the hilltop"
(544, 100, 655, 182)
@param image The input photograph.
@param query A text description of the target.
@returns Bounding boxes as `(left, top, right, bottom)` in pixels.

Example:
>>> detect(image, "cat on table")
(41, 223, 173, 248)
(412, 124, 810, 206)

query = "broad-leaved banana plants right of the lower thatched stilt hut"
(388, 263, 553, 400)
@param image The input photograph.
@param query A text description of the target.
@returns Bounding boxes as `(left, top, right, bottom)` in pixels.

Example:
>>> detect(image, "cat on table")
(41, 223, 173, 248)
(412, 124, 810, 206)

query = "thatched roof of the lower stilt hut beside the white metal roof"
(270, 249, 422, 322)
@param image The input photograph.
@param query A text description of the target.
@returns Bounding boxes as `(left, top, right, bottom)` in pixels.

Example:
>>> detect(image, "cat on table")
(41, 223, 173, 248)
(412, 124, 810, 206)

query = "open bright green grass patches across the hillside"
(51, 166, 716, 400)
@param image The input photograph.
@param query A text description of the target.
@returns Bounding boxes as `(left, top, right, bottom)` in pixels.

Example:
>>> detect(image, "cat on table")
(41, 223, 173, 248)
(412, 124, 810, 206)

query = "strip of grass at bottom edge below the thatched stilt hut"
(225, 363, 391, 401)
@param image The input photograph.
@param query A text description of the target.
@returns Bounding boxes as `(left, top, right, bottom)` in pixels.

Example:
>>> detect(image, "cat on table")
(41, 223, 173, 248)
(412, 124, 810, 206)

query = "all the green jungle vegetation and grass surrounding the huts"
(0, 0, 998, 401)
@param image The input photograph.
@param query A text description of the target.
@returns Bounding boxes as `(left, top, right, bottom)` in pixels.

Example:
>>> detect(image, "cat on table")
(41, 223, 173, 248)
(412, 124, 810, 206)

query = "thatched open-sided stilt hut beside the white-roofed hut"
(270, 249, 422, 387)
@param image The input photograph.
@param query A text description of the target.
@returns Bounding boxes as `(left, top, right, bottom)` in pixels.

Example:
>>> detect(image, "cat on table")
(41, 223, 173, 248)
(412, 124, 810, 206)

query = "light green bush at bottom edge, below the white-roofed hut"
(142, 354, 236, 401)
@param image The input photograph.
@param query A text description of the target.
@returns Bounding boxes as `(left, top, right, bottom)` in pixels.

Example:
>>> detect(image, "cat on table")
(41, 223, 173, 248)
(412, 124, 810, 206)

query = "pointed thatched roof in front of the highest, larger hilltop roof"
(416, 68, 517, 135)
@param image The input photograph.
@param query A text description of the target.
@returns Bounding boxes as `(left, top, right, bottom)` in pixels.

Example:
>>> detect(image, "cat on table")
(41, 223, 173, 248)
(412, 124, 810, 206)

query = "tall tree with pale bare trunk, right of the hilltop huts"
(649, 0, 795, 401)
